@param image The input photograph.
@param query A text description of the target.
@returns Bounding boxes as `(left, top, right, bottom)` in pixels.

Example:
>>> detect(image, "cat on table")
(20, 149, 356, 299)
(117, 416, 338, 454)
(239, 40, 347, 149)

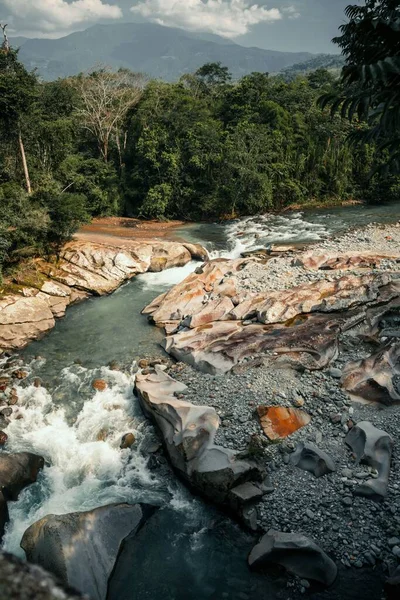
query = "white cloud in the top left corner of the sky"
(2, 0, 122, 34)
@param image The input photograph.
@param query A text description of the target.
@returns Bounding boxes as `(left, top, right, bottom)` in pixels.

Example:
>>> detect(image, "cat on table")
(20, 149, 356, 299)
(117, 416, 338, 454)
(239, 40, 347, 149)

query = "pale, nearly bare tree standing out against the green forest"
(73, 68, 146, 165)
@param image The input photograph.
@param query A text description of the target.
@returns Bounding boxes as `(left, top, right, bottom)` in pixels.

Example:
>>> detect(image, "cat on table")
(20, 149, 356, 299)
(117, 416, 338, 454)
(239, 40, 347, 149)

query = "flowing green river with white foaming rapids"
(0, 203, 400, 600)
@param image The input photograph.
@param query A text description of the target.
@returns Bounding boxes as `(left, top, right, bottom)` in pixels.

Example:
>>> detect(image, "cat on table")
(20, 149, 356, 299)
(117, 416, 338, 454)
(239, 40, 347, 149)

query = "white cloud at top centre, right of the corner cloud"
(131, 0, 283, 37)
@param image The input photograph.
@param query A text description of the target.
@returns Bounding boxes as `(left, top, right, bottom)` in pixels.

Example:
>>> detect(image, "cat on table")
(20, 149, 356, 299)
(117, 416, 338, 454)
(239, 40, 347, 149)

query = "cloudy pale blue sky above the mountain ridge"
(0, 0, 363, 53)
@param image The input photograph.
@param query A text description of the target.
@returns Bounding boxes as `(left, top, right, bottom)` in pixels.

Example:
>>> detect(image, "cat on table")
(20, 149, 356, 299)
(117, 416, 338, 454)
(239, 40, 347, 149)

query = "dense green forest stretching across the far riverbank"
(0, 0, 400, 282)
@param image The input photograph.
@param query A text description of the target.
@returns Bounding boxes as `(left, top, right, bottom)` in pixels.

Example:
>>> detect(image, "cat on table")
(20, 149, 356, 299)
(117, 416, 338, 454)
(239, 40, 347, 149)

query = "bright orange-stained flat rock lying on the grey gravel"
(257, 406, 311, 440)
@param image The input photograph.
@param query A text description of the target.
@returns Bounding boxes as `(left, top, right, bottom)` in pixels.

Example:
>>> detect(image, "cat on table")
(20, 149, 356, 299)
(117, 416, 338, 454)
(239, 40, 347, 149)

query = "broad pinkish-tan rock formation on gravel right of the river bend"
(143, 259, 400, 374)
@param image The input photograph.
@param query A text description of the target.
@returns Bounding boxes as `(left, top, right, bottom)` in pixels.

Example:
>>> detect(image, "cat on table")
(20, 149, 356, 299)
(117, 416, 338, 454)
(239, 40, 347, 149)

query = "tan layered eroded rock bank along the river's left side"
(0, 240, 207, 350)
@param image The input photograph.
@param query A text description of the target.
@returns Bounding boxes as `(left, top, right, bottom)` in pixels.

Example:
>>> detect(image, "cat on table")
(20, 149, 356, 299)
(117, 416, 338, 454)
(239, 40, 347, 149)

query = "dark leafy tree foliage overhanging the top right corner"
(320, 0, 400, 173)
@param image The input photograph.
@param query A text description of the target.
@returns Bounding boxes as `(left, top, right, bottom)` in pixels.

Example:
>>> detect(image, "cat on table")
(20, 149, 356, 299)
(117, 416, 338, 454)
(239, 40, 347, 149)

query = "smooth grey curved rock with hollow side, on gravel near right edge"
(346, 421, 393, 500)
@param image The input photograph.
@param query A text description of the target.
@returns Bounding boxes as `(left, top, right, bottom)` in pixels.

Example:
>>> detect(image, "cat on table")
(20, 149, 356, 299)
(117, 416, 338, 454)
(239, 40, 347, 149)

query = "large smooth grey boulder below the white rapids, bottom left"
(21, 504, 155, 600)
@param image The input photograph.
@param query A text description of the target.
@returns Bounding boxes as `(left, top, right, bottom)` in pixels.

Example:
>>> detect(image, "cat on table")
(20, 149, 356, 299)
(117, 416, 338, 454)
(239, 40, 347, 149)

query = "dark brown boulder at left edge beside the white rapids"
(0, 452, 44, 500)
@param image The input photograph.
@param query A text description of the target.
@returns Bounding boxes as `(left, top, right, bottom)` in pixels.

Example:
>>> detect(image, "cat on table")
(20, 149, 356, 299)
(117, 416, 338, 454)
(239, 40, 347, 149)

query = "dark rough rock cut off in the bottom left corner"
(0, 552, 84, 600)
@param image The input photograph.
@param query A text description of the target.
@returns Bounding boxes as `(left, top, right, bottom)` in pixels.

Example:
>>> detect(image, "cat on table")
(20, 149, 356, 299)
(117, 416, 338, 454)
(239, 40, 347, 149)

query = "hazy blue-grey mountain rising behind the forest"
(14, 23, 313, 81)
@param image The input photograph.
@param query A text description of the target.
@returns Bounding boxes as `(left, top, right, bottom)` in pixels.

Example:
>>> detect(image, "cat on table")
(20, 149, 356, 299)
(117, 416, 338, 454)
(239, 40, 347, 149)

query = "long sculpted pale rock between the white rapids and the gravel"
(136, 366, 264, 506)
